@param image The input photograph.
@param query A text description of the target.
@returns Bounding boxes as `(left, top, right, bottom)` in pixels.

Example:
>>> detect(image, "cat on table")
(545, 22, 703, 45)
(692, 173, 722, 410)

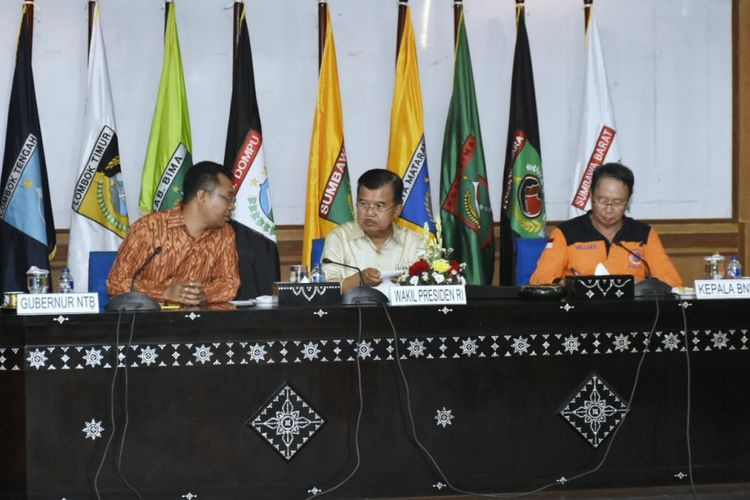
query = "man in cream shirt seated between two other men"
(323, 169, 424, 293)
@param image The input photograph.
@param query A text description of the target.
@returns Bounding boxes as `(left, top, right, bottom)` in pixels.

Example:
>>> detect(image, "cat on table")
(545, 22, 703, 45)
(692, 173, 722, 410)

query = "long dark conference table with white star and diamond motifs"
(0, 299, 750, 500)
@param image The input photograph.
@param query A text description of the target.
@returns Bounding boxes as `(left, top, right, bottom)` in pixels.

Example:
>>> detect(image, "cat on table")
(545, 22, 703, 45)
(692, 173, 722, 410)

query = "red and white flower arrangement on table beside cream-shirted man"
(396, 220, 466, 286)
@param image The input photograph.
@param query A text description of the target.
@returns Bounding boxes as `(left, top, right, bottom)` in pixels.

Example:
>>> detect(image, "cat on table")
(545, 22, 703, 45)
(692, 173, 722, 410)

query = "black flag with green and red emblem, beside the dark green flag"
(500, 4, 546, 285)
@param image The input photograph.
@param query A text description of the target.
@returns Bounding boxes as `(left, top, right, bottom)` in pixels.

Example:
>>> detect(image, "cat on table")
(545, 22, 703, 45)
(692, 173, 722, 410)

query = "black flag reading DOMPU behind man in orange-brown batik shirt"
(224, 2, 280, 299)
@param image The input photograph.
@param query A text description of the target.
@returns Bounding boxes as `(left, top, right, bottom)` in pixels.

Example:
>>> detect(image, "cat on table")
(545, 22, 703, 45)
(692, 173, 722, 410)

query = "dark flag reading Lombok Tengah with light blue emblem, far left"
(0, 3, 56, 292)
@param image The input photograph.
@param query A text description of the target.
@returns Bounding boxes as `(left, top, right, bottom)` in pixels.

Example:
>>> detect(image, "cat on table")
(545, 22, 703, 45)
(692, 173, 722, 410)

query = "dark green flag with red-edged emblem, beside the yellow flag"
(440, 9, 495, 285)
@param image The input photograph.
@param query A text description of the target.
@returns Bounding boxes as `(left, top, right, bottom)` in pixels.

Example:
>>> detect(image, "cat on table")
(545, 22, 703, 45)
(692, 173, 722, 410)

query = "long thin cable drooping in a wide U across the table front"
(382, 296, 668, 498)
